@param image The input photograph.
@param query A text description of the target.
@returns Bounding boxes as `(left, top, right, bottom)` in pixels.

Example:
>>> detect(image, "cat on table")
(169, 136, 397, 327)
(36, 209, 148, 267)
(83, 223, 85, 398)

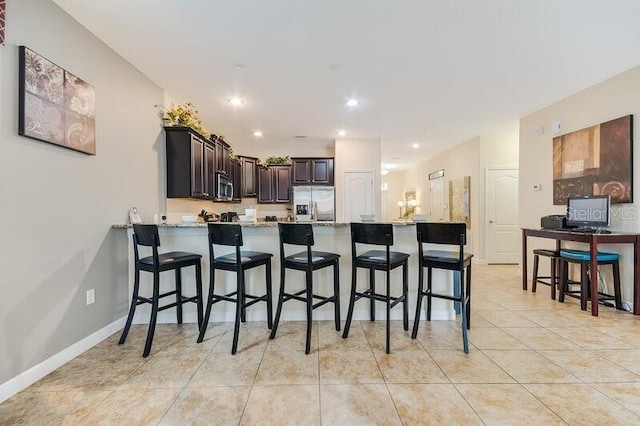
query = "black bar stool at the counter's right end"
(411, 222, 473, 354)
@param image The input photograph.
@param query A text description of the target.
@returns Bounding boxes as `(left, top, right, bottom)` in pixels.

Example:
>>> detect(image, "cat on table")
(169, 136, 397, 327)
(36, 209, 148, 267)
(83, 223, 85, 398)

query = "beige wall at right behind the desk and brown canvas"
(520, 67, 640, 301)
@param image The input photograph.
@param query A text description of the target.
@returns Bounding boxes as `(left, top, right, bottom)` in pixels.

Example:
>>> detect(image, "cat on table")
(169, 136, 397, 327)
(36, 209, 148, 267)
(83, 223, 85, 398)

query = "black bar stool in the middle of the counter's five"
(269, 223, 340, 354)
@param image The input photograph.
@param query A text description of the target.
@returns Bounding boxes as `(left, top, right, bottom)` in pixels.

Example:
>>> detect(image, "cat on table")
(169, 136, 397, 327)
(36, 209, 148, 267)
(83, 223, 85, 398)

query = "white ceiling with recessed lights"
(54, 0, 640, 168)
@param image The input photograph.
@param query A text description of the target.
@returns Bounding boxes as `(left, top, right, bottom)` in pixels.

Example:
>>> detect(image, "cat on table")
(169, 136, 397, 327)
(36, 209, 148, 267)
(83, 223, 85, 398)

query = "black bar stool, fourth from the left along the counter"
(342, 222, 409, 353)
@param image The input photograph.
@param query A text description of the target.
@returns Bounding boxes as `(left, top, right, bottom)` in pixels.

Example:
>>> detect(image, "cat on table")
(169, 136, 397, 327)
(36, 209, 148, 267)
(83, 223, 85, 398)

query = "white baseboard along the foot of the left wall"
(0, 317, 127, 403)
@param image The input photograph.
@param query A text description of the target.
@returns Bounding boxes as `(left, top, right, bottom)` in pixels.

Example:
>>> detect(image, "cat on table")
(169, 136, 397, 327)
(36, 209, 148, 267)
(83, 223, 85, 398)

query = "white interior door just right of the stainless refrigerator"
(342, 172, 376, 222)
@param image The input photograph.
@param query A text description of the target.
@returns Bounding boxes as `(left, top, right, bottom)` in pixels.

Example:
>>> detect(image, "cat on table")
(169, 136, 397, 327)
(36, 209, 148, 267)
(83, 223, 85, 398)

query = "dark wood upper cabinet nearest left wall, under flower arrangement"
(165, 127, 214, 199)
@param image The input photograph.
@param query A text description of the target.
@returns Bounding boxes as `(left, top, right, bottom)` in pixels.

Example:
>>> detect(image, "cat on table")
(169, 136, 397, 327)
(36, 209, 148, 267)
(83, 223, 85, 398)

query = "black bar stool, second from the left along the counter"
(198, 223, 273, 355)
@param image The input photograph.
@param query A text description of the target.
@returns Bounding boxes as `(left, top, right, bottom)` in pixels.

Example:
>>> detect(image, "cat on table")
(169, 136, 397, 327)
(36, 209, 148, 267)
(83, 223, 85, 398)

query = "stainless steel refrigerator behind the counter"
(293, 186, 336, 222)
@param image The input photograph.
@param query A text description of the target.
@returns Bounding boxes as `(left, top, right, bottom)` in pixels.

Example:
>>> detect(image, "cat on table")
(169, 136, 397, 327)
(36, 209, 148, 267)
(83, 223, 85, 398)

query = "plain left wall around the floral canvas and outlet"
(0, 0, 164, 384)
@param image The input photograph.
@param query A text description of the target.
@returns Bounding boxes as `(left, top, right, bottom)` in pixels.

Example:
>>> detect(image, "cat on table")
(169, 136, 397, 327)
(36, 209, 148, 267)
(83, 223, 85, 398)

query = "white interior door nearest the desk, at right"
(485, 169, 520, 263)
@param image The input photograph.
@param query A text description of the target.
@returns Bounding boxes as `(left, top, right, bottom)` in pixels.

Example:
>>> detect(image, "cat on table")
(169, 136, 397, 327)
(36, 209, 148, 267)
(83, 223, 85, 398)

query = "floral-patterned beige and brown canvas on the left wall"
(18, 46, 96, 155)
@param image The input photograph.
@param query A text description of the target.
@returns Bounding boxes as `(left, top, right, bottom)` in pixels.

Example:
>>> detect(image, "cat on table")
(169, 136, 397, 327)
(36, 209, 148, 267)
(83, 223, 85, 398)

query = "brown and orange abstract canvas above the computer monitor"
(553, 115, 633, 205)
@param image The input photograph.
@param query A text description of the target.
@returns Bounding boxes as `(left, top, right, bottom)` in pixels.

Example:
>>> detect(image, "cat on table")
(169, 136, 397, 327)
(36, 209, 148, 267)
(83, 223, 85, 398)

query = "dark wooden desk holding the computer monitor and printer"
(522, 228, 640, 316)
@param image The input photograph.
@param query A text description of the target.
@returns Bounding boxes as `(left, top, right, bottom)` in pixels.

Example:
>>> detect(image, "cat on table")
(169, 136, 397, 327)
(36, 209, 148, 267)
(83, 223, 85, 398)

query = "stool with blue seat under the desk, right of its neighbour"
(558, 249, 623, 311)
